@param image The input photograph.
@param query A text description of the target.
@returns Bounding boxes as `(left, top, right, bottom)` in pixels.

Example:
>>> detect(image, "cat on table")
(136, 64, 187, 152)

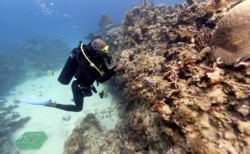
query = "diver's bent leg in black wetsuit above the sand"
(55, 81, 83, 112)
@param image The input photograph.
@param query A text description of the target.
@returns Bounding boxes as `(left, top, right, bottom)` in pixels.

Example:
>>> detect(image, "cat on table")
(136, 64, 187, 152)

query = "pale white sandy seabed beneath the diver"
(6, 71, 119, 154)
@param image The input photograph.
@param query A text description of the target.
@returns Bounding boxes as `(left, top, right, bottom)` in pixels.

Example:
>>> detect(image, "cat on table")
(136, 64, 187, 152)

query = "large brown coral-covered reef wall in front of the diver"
(65, 0, 250, 154)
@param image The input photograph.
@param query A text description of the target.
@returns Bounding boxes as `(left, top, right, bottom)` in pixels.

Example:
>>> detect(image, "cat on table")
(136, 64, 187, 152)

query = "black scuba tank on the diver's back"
(58, 48, 79, 85)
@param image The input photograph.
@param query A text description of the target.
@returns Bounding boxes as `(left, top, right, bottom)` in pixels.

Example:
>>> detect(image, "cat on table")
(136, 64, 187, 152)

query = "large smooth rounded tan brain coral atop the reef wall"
(210, 0, 250, 65)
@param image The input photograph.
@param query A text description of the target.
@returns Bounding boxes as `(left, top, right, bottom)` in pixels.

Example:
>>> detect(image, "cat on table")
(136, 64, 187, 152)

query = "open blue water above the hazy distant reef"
(0, 0, 183, 51)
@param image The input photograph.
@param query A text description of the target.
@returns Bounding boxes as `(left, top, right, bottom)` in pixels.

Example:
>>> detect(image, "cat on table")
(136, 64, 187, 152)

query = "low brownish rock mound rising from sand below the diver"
(64, 114, 123, 154)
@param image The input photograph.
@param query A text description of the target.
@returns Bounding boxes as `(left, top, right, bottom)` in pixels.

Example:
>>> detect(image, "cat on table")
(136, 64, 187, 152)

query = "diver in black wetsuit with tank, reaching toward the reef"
(47, 36, 123, 112)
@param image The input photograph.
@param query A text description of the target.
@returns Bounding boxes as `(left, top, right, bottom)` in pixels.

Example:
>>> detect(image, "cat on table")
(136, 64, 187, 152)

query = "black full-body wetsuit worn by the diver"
(56, 44, 115, 112)
